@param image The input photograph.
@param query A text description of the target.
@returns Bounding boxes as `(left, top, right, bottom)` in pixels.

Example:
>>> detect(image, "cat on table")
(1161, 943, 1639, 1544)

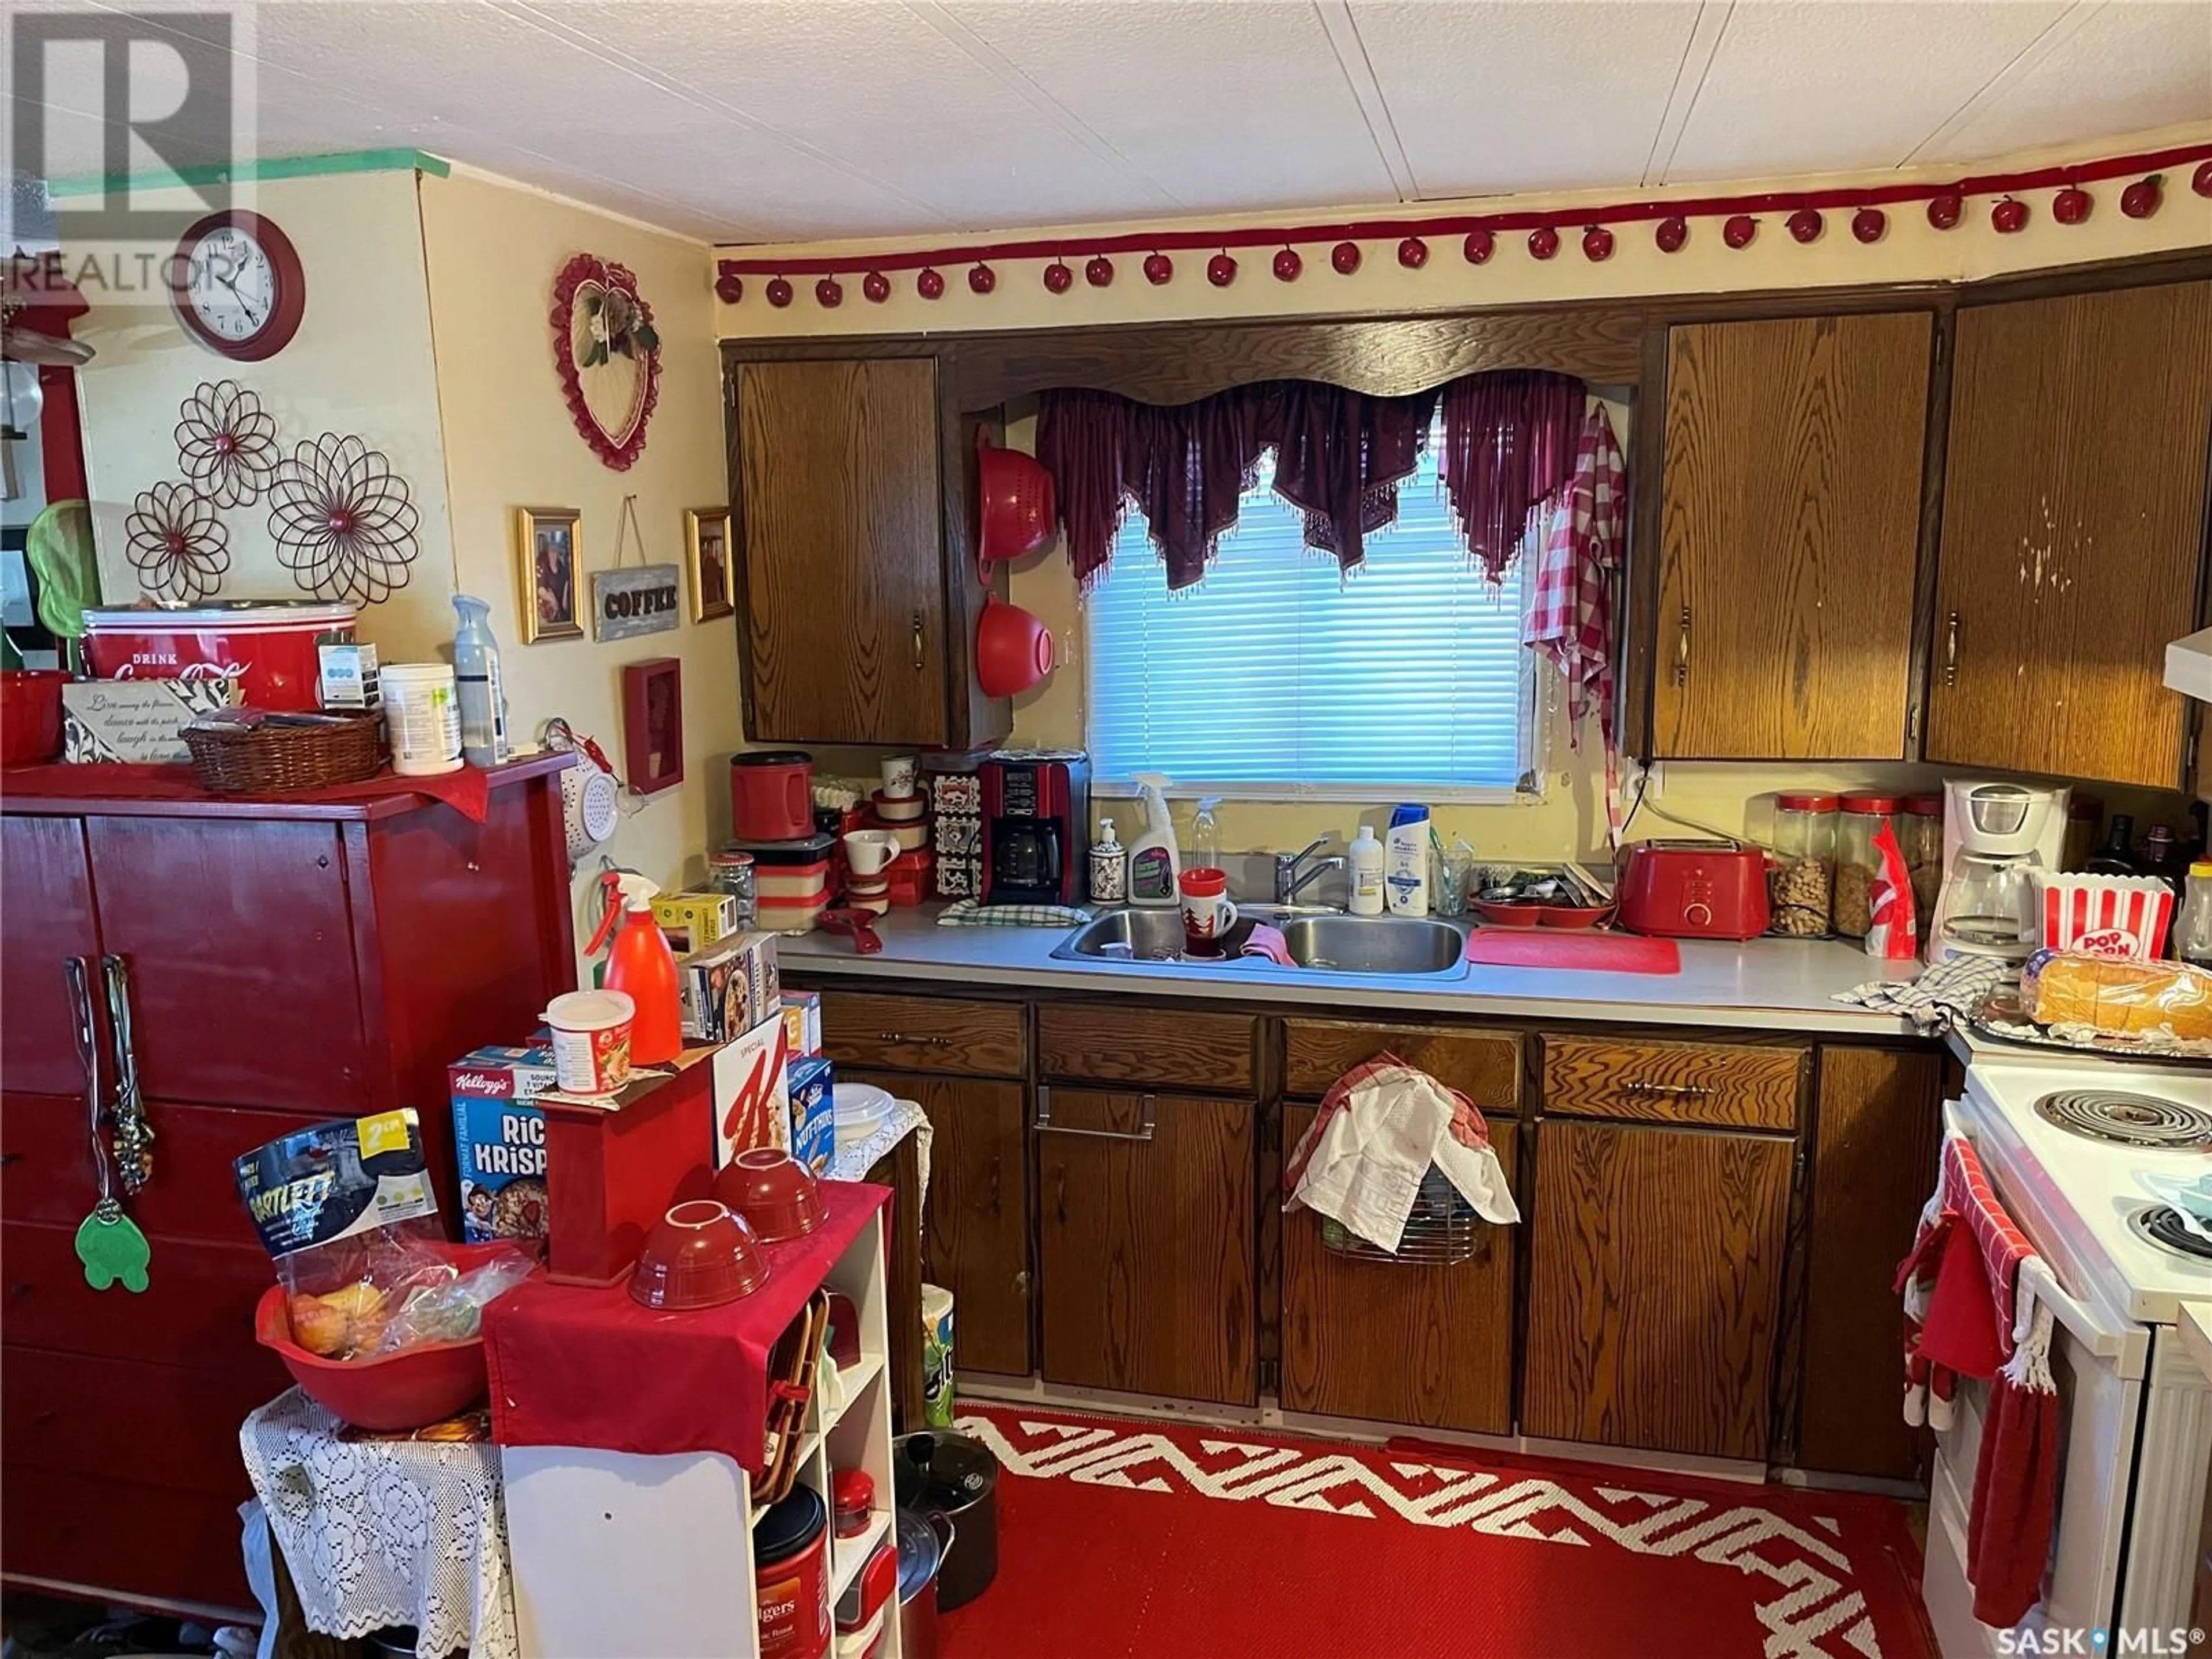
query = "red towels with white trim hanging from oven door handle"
(1898, 1132, 2059, 1630)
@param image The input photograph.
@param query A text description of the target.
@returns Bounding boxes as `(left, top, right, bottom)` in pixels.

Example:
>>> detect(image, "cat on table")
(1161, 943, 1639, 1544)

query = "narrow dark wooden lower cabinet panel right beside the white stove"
(1798, 1046, 1942, 1480)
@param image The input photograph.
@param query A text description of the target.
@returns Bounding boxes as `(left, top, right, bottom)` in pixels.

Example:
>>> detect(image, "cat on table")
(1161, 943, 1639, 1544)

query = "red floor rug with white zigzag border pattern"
(938, 1404, 1933, 1659)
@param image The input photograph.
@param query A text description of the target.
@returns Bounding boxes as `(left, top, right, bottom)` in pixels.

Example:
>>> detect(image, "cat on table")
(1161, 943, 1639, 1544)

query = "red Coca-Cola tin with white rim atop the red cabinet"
(84, 600, 356, 708)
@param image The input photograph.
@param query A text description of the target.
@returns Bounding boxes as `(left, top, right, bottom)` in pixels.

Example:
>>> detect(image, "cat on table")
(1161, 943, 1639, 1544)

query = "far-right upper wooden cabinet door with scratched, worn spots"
(1927, 283, 2212, 790)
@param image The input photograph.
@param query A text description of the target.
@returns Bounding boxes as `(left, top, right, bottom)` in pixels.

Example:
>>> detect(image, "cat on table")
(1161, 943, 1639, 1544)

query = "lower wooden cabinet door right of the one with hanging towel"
(1522, 1117, 1796, 1458)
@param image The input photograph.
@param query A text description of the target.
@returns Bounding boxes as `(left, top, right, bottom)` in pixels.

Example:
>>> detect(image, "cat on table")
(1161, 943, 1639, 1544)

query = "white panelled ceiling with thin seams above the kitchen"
(30, 0, 2212, 241)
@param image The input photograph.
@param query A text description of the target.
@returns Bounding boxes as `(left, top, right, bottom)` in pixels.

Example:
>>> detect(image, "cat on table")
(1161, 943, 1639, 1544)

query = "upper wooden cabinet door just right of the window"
(1652, 312, 1933, 761)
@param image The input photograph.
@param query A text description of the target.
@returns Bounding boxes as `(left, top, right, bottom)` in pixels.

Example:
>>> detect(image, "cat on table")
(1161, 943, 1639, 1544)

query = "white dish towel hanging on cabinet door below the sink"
(1283, 1053, 1520, 1254)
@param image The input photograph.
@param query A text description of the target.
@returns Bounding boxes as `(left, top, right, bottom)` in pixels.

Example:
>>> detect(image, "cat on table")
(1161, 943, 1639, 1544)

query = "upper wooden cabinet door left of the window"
(734, 358, 946, 743)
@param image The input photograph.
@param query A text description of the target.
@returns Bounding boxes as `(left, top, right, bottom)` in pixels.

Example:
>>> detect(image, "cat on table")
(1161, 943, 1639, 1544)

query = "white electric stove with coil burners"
(1922, 1059, 2212, 1659)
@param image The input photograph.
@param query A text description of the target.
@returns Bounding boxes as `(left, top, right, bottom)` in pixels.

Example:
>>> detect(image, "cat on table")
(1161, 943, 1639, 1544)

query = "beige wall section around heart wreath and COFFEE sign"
(421, 173, 741, 925)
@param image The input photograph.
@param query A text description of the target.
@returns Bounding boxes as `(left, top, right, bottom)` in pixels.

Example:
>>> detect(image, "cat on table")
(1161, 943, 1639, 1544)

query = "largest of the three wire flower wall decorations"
(270, 431, 422, 604)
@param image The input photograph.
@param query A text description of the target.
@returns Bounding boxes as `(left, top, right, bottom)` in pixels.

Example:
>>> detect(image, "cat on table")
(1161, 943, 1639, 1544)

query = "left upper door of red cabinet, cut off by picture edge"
(0, 816, 100, 1104)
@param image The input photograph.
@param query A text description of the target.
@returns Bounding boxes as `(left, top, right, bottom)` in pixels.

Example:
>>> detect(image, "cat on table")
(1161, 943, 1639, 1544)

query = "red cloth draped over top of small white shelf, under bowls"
(484, 1181, 892, 1471)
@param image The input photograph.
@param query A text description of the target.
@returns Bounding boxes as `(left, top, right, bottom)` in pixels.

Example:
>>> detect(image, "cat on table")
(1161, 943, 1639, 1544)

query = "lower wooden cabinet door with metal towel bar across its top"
(1037, 1088, 1259, 1404)
